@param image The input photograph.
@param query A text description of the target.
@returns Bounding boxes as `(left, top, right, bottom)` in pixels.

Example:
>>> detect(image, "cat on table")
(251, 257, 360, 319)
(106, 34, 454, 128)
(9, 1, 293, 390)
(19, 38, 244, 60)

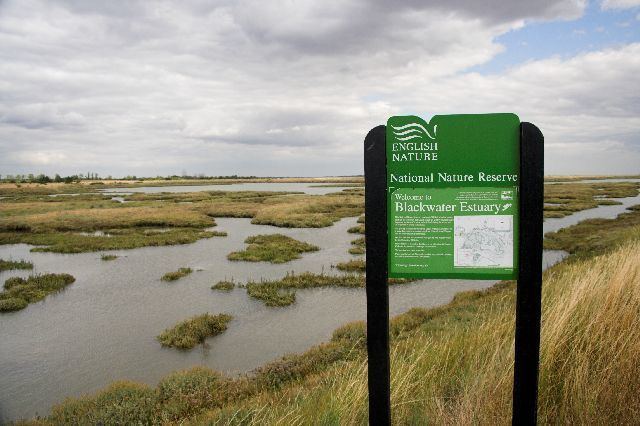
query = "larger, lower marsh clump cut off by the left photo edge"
(0, 274, 76, 312)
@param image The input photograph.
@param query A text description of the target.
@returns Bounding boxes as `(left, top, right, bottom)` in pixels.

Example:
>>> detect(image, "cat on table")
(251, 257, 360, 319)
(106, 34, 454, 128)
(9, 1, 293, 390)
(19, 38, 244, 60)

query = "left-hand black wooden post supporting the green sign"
(364, 126, 391, 425)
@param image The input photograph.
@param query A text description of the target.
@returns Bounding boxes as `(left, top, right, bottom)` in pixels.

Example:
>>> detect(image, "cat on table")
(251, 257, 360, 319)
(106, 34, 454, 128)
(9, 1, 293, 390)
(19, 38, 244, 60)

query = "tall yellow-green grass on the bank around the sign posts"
(202, 241, 640, 425)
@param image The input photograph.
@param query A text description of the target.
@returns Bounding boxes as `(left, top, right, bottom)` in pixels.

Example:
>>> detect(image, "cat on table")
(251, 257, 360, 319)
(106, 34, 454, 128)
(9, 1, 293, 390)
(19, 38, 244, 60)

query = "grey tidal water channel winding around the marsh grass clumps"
(0, 186, 640, 423)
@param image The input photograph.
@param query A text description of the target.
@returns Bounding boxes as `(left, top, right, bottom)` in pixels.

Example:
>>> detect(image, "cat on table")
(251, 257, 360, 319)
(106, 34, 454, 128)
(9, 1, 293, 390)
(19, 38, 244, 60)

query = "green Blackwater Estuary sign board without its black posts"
(386, 114, 520, 279)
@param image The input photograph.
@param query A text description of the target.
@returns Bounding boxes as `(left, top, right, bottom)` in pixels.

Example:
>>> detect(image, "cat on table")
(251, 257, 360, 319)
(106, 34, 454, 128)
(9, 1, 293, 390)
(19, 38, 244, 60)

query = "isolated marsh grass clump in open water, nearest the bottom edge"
(158, 313, 232, 349)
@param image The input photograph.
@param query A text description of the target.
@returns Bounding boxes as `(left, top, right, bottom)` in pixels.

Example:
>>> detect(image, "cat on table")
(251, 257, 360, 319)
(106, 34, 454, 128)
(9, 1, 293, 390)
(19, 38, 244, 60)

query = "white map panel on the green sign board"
(453, 215, 513, 268)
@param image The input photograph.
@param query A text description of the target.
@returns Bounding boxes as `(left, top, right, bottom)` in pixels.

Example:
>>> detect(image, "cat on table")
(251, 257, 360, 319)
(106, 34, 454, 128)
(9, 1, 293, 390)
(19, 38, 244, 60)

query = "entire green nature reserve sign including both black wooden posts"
(363, 114, 544, 426)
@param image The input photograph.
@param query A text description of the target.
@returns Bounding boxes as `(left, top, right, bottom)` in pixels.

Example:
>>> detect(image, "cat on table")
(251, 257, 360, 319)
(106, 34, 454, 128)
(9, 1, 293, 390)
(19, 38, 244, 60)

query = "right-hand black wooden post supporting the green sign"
(512, 123, 544, 425)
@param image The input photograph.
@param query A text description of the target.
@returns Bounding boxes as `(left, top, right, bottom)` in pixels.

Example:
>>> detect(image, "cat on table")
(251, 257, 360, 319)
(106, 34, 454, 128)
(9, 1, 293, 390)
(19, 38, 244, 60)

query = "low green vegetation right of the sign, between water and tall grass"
(544, 205, 640, 256)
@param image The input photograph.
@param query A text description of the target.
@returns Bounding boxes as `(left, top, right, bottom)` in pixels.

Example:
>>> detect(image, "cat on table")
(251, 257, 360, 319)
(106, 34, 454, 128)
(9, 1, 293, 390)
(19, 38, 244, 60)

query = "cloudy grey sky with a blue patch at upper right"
(0, 0, 640, 176)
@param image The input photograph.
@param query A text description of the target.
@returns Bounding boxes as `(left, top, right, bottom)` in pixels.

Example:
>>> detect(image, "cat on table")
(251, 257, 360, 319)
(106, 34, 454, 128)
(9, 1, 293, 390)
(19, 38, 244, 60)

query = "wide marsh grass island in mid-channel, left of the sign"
(227, 234, 320, 263)
